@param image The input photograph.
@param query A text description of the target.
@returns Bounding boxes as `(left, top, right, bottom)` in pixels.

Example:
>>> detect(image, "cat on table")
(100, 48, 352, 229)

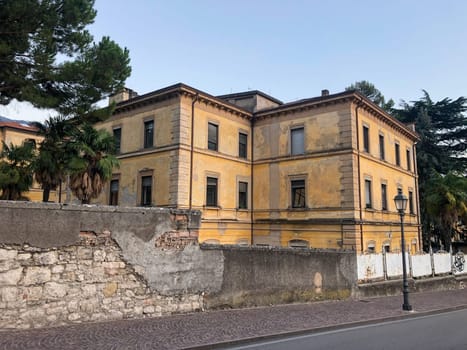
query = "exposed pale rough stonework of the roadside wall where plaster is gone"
(0, 232, 202, 328)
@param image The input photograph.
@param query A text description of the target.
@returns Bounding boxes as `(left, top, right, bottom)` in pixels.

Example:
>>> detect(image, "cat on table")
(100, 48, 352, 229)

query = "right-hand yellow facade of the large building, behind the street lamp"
(357, 104, 421, 252)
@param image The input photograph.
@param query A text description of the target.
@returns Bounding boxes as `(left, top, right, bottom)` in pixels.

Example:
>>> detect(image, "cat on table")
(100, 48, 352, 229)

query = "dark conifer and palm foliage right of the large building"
(392, 91, 467, 248)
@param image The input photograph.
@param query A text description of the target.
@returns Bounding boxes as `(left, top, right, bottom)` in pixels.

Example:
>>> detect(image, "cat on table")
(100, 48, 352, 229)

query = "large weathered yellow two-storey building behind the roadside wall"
(97, 84, 421, 252)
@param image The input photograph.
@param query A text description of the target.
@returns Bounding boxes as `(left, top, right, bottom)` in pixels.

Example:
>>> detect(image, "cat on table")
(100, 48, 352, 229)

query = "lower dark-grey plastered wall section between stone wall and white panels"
(202, 245, 357, 308)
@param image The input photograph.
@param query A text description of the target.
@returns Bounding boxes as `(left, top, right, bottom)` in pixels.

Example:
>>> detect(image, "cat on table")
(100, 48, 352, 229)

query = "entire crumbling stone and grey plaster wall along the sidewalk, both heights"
(0, 202, 357, 328)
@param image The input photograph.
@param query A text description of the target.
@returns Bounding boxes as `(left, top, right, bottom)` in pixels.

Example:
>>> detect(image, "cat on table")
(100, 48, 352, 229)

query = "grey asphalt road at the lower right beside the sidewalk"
(228, 309, 467, 350)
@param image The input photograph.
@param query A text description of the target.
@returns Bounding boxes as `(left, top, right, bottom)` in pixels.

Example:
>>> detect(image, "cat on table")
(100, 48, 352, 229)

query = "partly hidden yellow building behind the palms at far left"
(0, 118, 55, 202)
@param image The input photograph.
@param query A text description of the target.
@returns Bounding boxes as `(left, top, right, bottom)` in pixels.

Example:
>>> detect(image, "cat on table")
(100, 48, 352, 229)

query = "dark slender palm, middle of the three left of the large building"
(33, 116, 76, 202)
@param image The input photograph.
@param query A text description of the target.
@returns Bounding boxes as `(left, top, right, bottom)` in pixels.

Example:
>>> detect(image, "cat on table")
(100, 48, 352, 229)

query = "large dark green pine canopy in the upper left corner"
(0, 0, 131, 117)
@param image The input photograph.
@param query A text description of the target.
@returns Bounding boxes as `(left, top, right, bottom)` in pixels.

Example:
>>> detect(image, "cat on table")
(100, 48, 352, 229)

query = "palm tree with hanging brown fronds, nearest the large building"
(69, 124, 119, 204)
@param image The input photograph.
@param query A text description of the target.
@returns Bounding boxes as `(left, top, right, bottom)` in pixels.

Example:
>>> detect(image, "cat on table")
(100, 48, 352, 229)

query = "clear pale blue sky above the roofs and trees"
(0, 0, 467, 120)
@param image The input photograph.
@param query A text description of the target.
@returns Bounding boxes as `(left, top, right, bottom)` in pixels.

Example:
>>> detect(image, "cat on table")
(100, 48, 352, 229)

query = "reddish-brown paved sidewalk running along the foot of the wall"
(0, 289, 467, 349)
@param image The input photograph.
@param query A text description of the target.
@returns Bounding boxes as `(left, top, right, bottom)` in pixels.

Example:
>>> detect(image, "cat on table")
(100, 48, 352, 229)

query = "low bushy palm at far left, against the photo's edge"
(0, 142, 35, 200)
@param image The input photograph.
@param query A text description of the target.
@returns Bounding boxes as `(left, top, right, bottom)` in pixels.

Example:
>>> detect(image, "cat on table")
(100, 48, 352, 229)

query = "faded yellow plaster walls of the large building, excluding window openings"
(97, 87, 419, 251)
